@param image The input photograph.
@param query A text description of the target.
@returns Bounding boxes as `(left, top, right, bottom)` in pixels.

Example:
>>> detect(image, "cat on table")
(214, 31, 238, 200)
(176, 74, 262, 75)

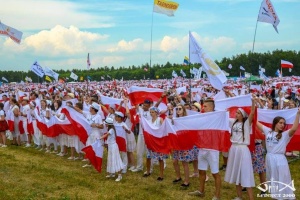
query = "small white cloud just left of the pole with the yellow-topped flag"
(107, 38, 143, 53)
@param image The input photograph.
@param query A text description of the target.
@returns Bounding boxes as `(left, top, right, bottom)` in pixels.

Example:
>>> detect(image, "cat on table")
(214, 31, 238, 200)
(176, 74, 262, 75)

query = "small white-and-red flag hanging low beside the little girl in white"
(82, 140, 103, 173)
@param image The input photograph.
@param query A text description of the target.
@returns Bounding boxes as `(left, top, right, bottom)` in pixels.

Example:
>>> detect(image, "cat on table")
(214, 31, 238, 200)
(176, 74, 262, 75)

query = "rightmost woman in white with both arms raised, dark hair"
(257, 109, 300, 199)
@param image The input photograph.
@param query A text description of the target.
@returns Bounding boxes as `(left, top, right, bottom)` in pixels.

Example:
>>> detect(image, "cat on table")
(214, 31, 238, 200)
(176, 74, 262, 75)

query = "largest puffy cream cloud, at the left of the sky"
(4, 25, 108, 56)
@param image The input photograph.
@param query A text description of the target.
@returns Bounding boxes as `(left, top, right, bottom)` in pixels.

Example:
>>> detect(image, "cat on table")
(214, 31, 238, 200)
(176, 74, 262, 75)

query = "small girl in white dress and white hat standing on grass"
(100, 118, 124, 182)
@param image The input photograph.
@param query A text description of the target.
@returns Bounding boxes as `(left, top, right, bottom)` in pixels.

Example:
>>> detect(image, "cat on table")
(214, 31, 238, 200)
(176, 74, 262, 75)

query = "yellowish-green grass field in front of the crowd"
(0, 146, 300, 200)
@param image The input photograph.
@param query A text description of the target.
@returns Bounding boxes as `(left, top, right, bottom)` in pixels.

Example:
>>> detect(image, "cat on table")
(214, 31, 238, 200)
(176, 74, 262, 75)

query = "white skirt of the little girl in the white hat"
(106, 143, 124, 174)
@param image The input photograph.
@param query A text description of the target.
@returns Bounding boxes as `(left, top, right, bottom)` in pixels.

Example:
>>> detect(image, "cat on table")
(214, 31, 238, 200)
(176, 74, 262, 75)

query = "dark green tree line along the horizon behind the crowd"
(0, 50, 300, 82)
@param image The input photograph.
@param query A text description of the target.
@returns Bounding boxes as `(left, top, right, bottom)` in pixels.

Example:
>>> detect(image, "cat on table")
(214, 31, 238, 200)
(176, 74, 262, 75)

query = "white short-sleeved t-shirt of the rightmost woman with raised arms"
(263, 126, 292, 154)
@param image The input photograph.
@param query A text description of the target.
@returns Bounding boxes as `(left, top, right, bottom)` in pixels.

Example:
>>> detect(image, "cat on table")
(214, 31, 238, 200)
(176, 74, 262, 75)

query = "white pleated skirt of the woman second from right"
(224, 144, 255, 187)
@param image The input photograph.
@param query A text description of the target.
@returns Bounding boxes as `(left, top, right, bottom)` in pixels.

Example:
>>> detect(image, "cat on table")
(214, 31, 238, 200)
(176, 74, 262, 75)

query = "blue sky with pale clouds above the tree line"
(0, 0, 300, 71)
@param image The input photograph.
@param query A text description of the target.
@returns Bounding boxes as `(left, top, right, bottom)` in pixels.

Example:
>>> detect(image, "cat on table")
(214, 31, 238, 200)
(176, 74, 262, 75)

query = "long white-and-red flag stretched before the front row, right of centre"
(141, 111, 231, 154)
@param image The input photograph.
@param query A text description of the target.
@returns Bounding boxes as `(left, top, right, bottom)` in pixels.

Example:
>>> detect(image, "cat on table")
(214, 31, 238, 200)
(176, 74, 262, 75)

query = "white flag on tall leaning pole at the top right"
(257, 0, 280, 33)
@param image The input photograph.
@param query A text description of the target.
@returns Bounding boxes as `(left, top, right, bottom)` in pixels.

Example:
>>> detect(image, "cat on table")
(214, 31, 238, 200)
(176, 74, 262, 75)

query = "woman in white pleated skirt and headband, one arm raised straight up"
(224, 99, 255, 200)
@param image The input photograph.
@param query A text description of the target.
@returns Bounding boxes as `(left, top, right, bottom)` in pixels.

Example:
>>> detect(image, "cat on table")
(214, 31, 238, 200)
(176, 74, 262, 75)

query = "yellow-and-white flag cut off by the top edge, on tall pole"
(153, 0, 179, 17)
